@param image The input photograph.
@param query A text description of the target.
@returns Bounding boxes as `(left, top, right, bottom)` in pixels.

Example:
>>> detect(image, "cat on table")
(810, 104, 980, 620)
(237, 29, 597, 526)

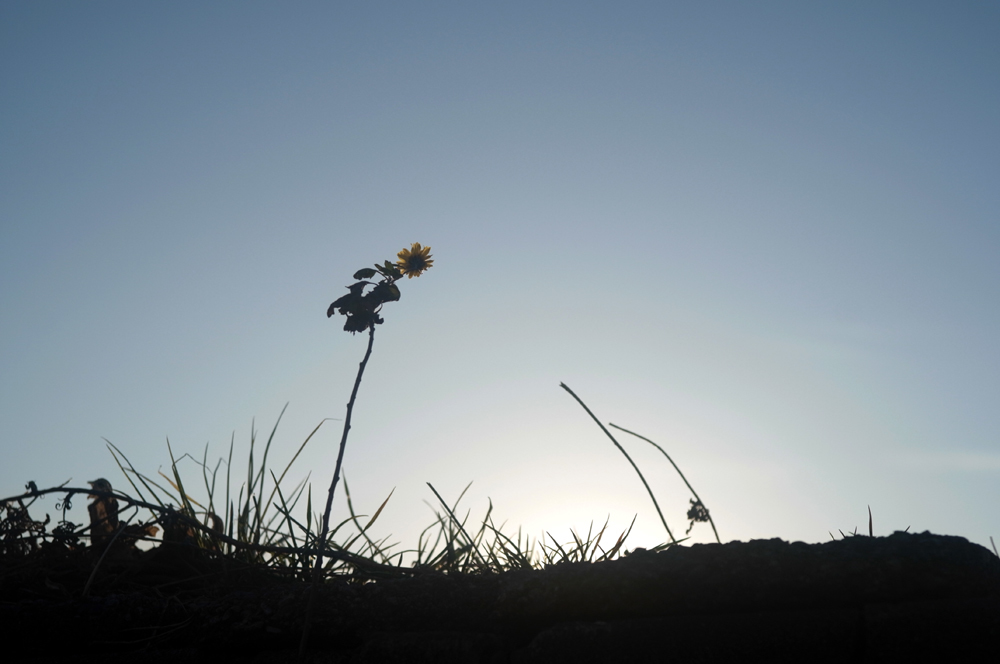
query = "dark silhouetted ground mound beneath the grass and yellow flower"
(0, 533, 1000, 664)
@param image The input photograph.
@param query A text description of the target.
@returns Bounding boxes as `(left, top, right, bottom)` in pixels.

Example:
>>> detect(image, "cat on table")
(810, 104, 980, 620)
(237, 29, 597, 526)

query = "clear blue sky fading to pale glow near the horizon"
(0, 1, 1000, 550)
